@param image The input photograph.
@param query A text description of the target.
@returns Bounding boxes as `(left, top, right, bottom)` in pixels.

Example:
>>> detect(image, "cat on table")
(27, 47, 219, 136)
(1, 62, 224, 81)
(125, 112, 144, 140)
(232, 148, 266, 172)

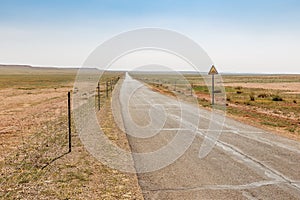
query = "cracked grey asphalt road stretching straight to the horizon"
(119, 75, 300, 199)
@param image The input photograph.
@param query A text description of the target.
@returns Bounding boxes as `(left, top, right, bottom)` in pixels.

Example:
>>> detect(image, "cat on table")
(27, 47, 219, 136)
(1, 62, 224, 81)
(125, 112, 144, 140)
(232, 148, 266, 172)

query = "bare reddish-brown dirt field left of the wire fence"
(0, 85, 71, 161)
